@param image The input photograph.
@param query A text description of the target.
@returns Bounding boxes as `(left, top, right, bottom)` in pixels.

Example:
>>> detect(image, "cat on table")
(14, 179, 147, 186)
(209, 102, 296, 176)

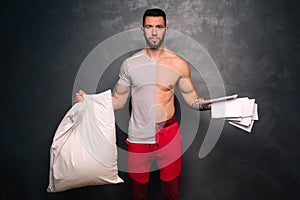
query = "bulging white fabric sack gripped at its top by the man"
(47, 90, 123, 192)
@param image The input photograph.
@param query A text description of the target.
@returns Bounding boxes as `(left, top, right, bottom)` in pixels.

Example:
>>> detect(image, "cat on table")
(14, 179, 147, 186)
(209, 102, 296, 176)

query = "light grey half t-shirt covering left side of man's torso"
(118, 50, 157, 144)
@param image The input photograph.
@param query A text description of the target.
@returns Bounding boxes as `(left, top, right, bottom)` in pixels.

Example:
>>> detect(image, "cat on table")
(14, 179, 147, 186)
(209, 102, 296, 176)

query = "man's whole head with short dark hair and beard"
(142, 8, 168, 49)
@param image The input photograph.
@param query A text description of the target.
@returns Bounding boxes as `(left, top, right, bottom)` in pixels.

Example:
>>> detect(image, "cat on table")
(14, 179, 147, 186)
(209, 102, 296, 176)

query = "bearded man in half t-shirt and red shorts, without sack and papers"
(75, 8, 210, 200)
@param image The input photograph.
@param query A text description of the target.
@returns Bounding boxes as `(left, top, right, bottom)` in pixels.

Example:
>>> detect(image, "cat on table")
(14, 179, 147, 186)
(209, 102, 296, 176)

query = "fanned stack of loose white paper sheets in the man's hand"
(207, 95, 258, 133)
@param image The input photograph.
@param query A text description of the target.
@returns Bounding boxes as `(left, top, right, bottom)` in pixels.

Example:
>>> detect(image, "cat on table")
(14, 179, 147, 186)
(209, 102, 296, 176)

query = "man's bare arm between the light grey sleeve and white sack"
(112, 84, 130, 110)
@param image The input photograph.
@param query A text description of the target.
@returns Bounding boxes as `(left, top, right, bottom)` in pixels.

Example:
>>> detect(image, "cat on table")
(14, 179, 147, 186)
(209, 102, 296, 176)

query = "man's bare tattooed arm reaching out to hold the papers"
(178, 61, 211, 110)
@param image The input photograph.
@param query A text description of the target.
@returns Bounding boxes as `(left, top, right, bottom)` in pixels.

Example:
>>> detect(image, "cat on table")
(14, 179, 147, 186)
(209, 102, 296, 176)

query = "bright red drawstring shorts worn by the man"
(126, 117, 182, 183)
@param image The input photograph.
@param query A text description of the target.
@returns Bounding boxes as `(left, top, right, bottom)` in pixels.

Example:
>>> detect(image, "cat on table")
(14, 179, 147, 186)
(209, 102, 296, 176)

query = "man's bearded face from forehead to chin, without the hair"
(142, 16, 168, 49)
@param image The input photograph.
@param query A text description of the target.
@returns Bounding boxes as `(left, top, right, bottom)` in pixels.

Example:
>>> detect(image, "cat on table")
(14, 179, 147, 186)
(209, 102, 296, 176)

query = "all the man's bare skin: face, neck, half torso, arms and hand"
(75, 16, 210, 122)
